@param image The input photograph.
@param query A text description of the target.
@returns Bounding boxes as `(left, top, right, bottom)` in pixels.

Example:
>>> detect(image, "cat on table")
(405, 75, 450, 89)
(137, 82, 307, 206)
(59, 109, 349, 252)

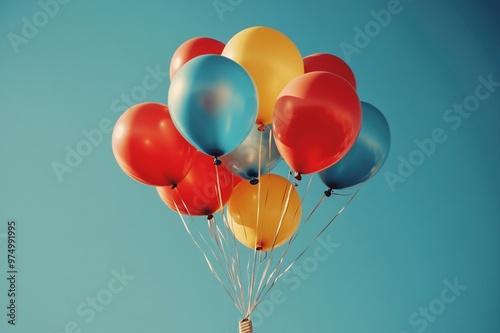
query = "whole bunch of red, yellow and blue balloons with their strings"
(112, 26, 391, 332)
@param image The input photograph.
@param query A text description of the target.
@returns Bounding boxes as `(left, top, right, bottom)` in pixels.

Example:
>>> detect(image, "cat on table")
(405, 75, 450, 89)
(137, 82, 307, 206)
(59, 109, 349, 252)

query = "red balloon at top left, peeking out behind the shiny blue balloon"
(170, 37, 225, 81)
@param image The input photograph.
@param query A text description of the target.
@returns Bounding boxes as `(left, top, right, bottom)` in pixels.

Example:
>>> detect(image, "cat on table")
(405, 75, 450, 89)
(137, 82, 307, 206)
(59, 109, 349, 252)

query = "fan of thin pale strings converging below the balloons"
(170, 126, 359, 319)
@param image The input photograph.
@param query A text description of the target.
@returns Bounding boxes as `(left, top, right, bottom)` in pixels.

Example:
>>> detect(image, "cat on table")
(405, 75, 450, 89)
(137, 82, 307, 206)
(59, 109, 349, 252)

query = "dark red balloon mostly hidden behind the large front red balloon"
(304, 53, 356, 90)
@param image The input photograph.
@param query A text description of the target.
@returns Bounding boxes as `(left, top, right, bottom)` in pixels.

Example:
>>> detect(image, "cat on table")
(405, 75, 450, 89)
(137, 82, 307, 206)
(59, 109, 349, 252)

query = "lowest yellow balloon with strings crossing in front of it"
(227, 174, 302, 251)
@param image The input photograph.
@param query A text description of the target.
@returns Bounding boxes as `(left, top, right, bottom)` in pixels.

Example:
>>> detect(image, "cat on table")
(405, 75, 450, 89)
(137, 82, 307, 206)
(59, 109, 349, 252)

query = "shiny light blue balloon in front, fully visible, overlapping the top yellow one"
(168, 54, 258, 157)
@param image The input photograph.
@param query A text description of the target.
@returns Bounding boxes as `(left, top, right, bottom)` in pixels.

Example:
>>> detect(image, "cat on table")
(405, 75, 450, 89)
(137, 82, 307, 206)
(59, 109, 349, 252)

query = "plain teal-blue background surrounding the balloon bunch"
(0, 0, 500, 333)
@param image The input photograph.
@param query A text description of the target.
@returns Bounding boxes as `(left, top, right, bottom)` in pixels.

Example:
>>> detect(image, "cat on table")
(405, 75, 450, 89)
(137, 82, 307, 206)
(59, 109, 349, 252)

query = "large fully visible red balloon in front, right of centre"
(273, 72, 362, 174)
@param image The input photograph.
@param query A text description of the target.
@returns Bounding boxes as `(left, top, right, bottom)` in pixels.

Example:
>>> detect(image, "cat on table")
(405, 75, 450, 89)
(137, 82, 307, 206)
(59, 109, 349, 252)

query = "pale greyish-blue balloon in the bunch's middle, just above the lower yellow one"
(221, 126, 281, 183)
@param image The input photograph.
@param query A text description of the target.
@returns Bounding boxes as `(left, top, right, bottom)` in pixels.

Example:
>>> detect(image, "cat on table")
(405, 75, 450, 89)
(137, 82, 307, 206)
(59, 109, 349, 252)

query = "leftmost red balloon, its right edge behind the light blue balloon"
(112, 103, 196, 186)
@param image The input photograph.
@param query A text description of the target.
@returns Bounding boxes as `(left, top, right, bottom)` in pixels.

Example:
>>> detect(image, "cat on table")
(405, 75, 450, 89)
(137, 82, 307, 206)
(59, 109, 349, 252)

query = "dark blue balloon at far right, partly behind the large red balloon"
(319, 102, 391, 190)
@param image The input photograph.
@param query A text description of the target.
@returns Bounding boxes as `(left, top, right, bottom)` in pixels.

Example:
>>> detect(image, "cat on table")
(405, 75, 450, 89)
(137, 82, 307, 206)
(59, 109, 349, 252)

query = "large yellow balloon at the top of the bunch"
(222, 27, 304, 125)
